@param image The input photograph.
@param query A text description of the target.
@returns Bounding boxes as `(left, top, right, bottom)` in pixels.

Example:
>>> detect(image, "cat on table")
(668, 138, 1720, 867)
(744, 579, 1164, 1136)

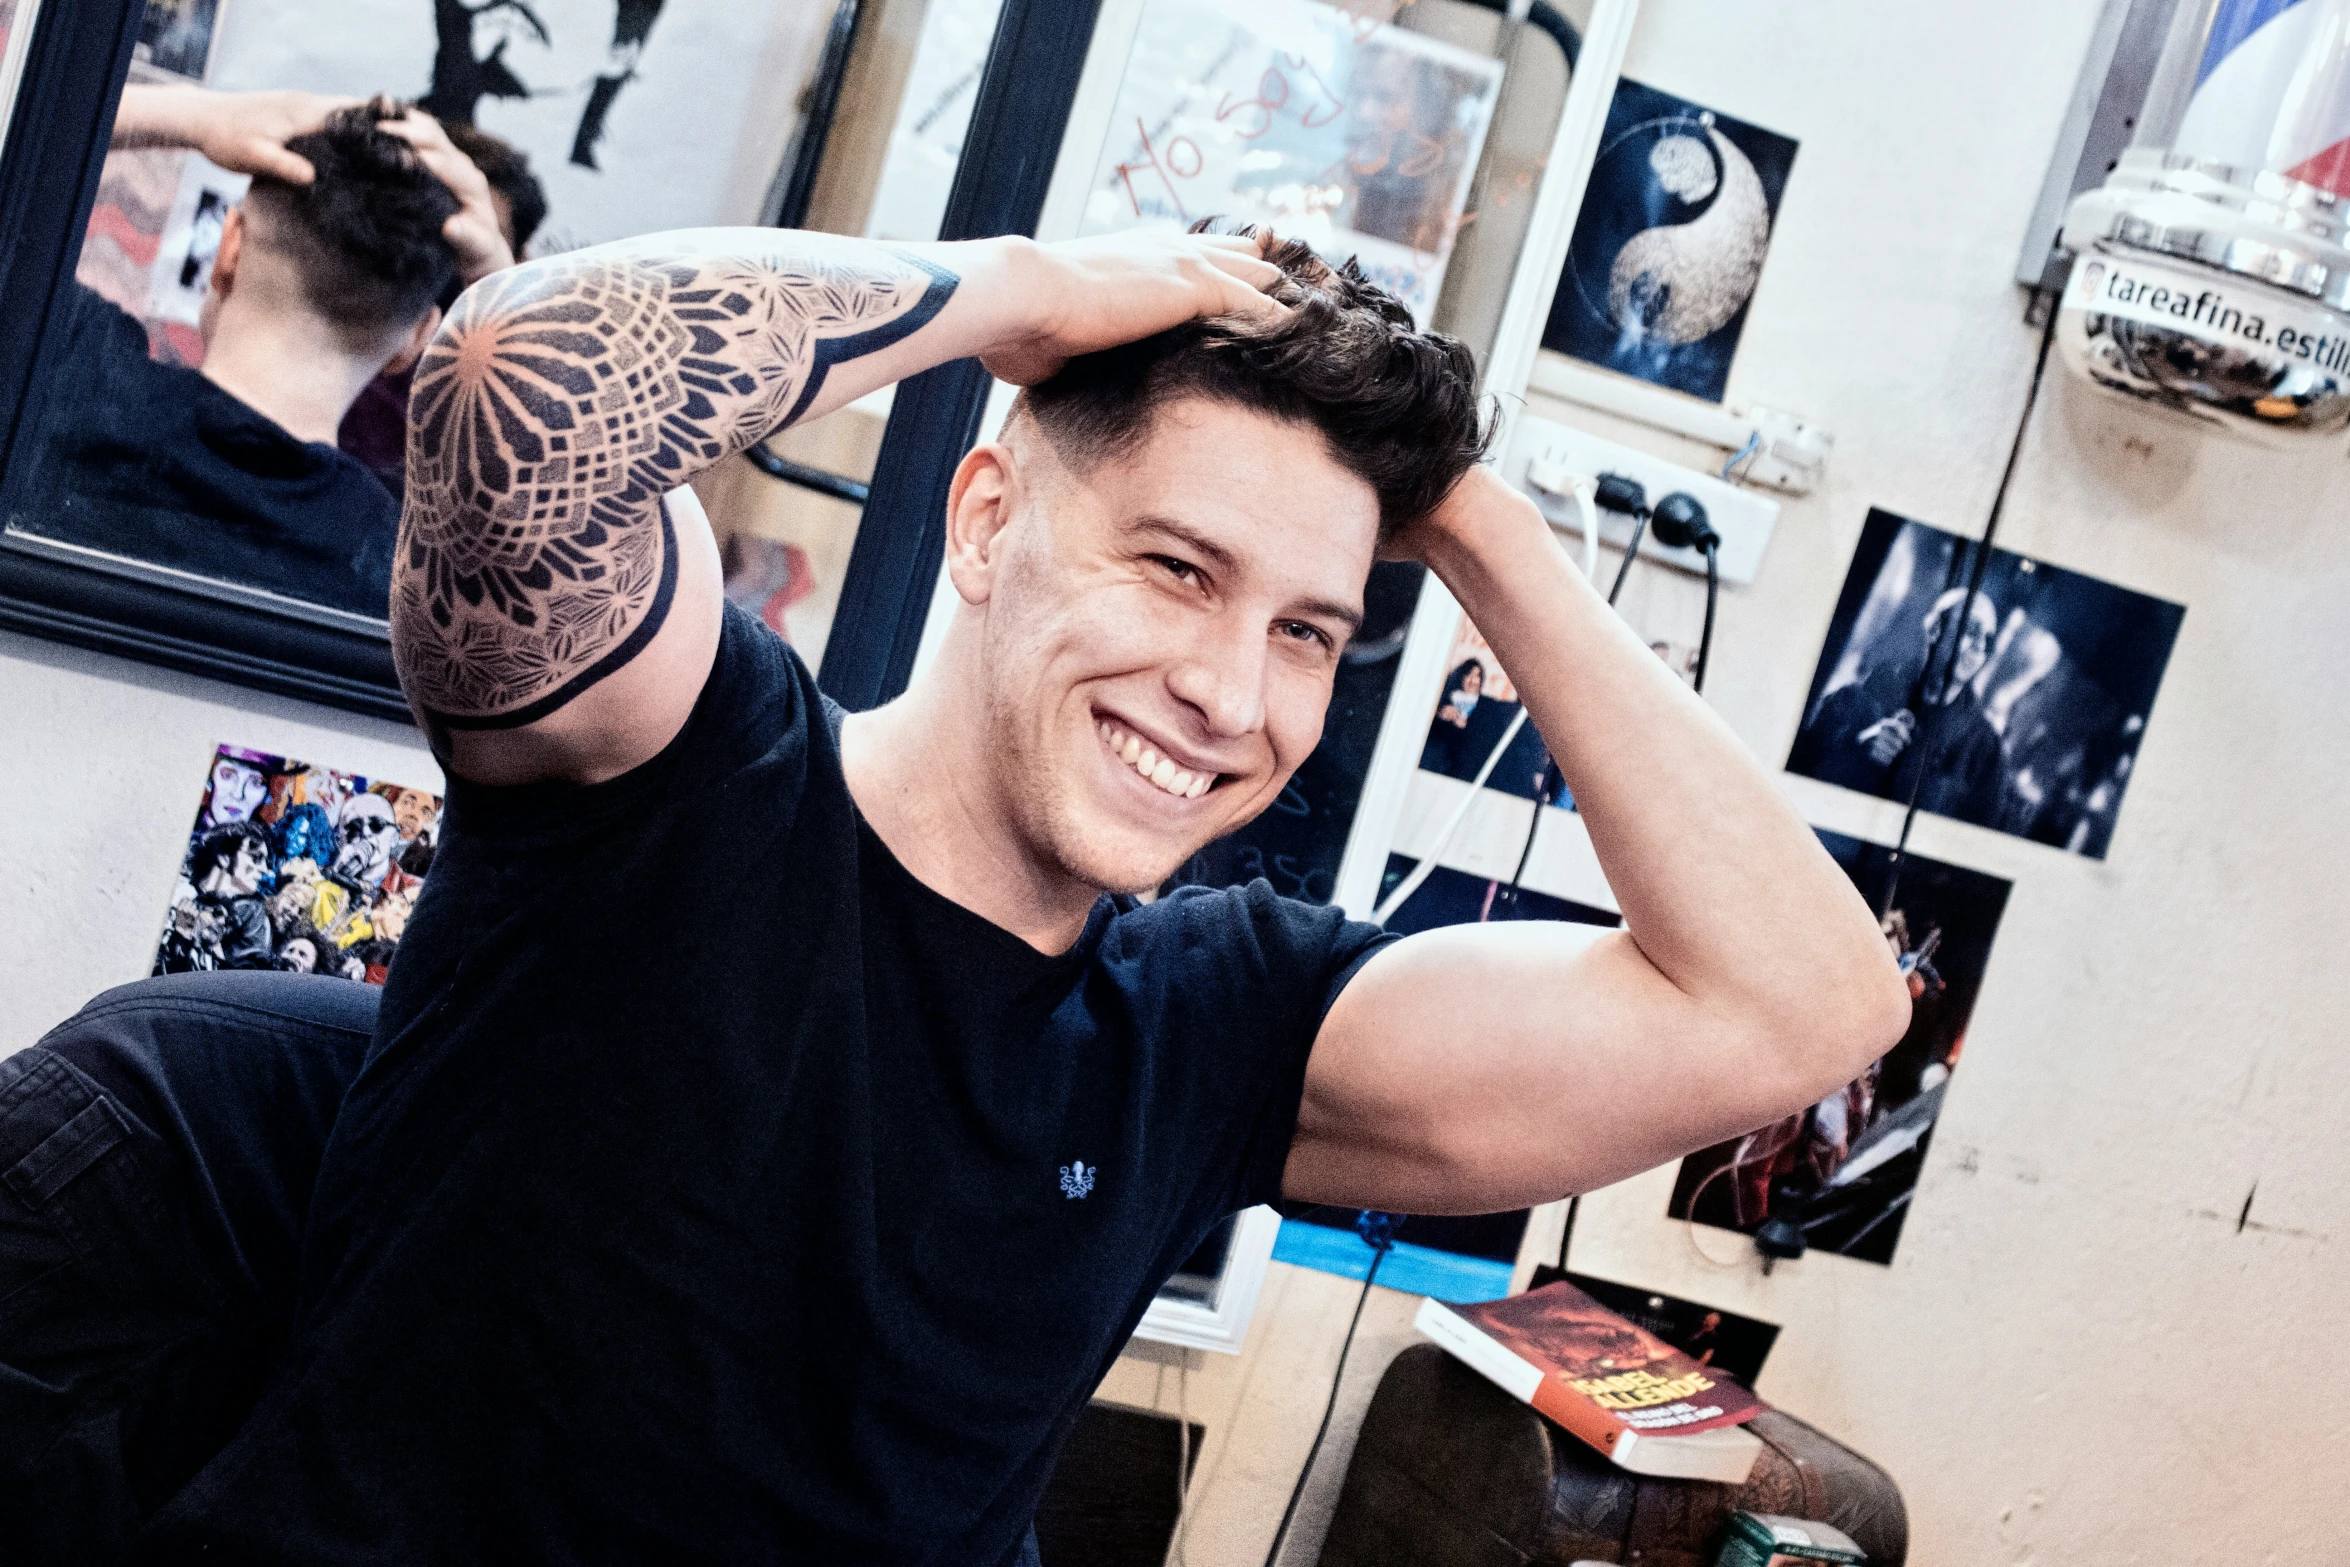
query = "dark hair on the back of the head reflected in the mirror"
(247, 99, 456, 352)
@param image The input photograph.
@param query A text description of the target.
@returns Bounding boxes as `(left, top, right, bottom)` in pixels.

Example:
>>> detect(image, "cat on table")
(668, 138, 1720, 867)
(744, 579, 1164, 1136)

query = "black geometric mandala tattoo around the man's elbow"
(392, 251, 956, 728)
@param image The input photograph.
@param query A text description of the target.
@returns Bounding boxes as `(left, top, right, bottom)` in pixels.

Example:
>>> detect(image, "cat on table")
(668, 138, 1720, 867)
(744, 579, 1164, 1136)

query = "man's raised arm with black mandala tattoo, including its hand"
(392, 228, 1278, 782)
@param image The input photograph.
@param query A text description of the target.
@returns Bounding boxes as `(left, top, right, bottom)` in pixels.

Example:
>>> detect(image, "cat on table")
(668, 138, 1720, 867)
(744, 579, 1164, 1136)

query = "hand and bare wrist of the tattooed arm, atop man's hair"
(980, 230, 1283, 385)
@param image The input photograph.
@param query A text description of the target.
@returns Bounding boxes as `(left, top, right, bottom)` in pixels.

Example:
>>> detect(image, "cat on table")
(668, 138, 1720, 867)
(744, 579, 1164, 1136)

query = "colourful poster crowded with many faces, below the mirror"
(150, 745, 442, 984)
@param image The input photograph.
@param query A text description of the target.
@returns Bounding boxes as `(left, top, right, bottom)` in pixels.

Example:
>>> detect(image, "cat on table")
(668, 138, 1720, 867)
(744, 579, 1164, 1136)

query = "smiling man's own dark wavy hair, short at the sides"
(1018, 223, 1492, 540)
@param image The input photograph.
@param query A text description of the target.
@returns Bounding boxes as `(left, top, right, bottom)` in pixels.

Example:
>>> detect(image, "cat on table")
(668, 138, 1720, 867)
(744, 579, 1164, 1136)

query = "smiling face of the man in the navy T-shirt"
(982, 399, 1379, 890)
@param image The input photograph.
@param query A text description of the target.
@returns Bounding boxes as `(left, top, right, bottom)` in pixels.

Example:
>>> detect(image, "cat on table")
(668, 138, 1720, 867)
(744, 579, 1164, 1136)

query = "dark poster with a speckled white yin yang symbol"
(1542, 80, 1795, 402)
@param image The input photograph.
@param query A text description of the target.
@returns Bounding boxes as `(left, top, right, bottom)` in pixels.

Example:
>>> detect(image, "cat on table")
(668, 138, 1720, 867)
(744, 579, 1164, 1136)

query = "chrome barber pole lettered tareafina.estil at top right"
(2056, 0, 2350, 444)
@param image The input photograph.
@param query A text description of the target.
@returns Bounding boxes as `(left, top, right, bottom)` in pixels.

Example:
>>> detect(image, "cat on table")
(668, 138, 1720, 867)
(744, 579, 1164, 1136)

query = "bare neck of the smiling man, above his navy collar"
(841, 639, 1102, 951)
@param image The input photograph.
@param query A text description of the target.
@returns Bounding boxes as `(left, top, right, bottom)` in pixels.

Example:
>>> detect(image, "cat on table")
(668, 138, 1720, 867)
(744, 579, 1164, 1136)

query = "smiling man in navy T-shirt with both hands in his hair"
(148, 230, 1906, 1567)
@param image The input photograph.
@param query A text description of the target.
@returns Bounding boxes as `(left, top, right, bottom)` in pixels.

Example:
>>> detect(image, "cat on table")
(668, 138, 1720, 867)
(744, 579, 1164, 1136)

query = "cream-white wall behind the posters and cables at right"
(1105, 0, 2350, 1567)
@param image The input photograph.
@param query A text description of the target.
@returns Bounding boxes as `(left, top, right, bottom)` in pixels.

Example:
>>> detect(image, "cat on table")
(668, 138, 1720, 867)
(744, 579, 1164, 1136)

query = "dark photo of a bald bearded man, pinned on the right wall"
(1786, 510, 2186, 860)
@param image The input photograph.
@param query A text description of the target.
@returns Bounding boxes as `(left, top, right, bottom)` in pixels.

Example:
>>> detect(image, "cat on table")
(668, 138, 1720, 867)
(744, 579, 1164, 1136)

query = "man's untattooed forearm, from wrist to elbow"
(1426, 475, 1896, 1078)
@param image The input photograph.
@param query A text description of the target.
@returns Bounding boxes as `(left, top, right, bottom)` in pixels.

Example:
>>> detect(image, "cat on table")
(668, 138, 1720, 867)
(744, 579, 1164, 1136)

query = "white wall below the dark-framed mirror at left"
(0, 632, 442, 1055)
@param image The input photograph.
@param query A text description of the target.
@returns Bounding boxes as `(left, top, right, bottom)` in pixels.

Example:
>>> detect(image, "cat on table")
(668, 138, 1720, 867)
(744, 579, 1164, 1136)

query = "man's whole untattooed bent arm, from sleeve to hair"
(1283, 468, 1908, 1212)
